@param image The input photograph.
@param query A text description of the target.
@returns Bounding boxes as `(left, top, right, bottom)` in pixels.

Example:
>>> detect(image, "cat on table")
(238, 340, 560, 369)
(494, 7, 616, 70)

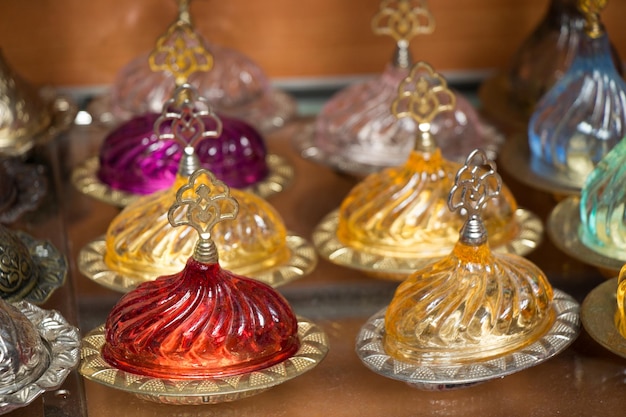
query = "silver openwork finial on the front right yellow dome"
(448, 149, 502, 246)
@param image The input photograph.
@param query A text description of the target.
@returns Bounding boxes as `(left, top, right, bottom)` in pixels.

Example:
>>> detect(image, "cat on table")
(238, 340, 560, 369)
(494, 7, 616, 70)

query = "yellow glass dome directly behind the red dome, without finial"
(104, 175, 290, 281)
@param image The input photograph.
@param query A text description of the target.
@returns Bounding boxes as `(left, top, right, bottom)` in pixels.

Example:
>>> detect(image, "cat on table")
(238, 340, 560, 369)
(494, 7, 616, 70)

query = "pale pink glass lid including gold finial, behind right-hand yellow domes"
(294, 1, 504, 175)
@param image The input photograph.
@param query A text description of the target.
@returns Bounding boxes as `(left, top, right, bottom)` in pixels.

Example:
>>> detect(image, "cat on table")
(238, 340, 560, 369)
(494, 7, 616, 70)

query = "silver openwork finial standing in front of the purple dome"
(154, 84, 222, 177)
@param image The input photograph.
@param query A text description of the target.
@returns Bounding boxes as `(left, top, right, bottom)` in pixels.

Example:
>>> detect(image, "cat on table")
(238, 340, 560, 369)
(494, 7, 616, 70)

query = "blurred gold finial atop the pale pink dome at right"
(372, 0, 435, 68)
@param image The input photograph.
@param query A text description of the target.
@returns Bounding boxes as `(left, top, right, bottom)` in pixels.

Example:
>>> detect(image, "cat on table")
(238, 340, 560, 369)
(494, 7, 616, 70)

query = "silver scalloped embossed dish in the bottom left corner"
(0, 301, 80, 414)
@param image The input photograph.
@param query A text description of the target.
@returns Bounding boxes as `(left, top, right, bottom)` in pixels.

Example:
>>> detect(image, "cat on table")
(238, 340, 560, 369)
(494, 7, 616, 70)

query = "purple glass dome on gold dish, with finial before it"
(72, 83, 294, 206)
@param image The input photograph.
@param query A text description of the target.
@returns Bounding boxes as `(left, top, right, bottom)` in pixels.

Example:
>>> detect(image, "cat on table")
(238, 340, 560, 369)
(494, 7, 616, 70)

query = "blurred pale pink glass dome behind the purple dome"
(90, 0, 296, 132)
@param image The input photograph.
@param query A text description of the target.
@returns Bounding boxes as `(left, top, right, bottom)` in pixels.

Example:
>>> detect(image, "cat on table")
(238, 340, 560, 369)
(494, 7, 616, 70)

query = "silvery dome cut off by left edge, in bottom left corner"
(0, 299, 50, 395)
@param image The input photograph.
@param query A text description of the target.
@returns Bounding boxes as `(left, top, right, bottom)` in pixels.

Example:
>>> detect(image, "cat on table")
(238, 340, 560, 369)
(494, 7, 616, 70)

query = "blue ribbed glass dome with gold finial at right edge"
(528, 2, 626, 186)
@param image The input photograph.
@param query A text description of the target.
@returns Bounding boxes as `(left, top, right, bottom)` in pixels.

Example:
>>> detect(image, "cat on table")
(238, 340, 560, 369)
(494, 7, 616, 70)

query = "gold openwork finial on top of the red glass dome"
(167, 169, 239, 263)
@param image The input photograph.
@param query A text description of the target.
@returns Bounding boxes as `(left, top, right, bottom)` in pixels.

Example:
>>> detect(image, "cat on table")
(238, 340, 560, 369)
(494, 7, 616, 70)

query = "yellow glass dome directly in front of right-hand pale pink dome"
(337, 148, 520, 259)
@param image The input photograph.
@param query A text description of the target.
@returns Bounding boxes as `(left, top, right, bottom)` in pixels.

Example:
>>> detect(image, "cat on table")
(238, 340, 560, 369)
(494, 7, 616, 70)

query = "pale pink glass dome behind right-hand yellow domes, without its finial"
(313, 64, 499, 169)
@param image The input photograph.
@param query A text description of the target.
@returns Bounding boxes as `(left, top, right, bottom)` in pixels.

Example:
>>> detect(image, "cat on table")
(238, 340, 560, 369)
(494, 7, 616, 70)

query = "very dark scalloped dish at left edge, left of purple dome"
(0, 159, 48, 224)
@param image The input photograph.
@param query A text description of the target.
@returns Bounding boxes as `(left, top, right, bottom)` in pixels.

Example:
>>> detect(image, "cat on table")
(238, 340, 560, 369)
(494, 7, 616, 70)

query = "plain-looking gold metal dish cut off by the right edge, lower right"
(580, 278, 626, 358)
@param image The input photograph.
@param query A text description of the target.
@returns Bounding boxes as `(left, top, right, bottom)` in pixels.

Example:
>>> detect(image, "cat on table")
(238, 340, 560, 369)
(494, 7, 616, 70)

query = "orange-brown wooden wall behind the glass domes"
(0, 0, 626, 86)
